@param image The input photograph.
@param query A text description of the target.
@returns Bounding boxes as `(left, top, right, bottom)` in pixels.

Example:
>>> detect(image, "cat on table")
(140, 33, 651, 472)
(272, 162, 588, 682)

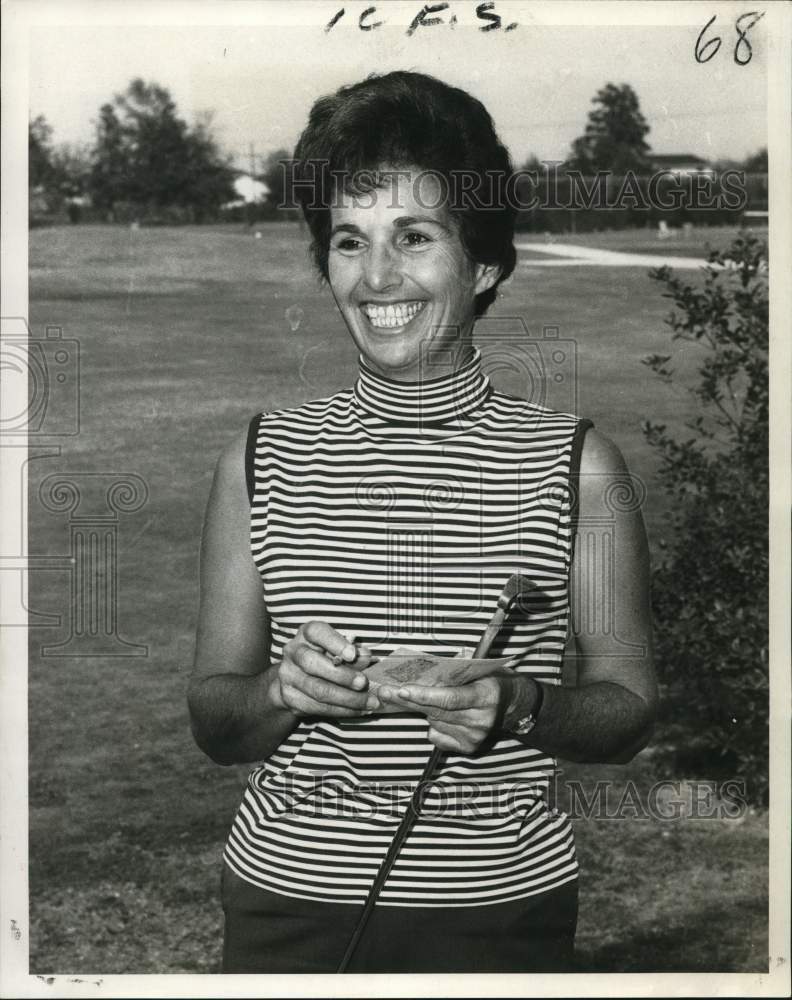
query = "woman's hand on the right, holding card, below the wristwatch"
(377, 676, 511, 755)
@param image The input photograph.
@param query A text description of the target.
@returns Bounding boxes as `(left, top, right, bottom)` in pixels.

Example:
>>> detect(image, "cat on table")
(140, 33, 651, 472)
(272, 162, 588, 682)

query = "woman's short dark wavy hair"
(291, 71, 516, 316)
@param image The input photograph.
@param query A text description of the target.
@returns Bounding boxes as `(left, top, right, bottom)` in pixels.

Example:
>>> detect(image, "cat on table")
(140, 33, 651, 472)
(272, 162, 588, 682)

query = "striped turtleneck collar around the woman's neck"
(354, 347, 490, 424)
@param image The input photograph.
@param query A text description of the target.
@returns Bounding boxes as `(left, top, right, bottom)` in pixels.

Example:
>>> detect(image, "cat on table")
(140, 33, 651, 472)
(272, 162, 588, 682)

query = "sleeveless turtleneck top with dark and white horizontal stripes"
(225, 350, 590, 906)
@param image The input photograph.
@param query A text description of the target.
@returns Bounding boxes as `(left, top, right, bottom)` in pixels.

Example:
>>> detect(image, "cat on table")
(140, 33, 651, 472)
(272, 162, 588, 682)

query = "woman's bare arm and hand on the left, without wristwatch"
(187, 434, 380, 764)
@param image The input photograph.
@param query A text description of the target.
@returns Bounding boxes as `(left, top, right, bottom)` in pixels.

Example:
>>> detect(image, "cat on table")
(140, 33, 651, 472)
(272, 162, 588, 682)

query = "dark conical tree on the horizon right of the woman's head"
(568, 83, 649, 174)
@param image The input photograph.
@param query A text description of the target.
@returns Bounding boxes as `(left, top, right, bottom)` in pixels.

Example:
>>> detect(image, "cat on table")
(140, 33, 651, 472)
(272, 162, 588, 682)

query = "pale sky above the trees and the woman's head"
(29, 0, 767, 167)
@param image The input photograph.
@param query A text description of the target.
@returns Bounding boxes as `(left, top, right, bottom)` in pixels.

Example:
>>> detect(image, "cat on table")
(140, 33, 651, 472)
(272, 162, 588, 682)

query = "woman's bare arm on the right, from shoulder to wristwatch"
(504, 430, 657, 763)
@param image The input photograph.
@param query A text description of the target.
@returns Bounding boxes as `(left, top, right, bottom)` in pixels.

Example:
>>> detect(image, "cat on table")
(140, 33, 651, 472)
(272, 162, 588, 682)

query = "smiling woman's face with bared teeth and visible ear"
(328, 168, 498, 382)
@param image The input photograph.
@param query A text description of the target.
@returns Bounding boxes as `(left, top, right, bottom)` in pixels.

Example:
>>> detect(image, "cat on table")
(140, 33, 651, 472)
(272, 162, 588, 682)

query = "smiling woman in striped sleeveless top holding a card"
(189, 72, 656, 972)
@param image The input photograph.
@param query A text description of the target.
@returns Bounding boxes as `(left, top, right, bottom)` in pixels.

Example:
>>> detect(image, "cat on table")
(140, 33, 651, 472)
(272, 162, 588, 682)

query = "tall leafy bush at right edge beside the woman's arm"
(643, 230, 769, 803)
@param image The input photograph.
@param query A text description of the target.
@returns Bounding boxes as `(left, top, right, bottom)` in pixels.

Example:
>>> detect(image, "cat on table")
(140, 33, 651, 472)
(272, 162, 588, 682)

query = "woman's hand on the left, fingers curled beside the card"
(270, 621, 381, 718)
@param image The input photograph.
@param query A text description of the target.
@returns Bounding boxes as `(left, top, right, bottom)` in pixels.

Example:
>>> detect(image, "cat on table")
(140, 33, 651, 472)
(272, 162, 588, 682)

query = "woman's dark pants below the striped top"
(223, 866, 577, 973)
